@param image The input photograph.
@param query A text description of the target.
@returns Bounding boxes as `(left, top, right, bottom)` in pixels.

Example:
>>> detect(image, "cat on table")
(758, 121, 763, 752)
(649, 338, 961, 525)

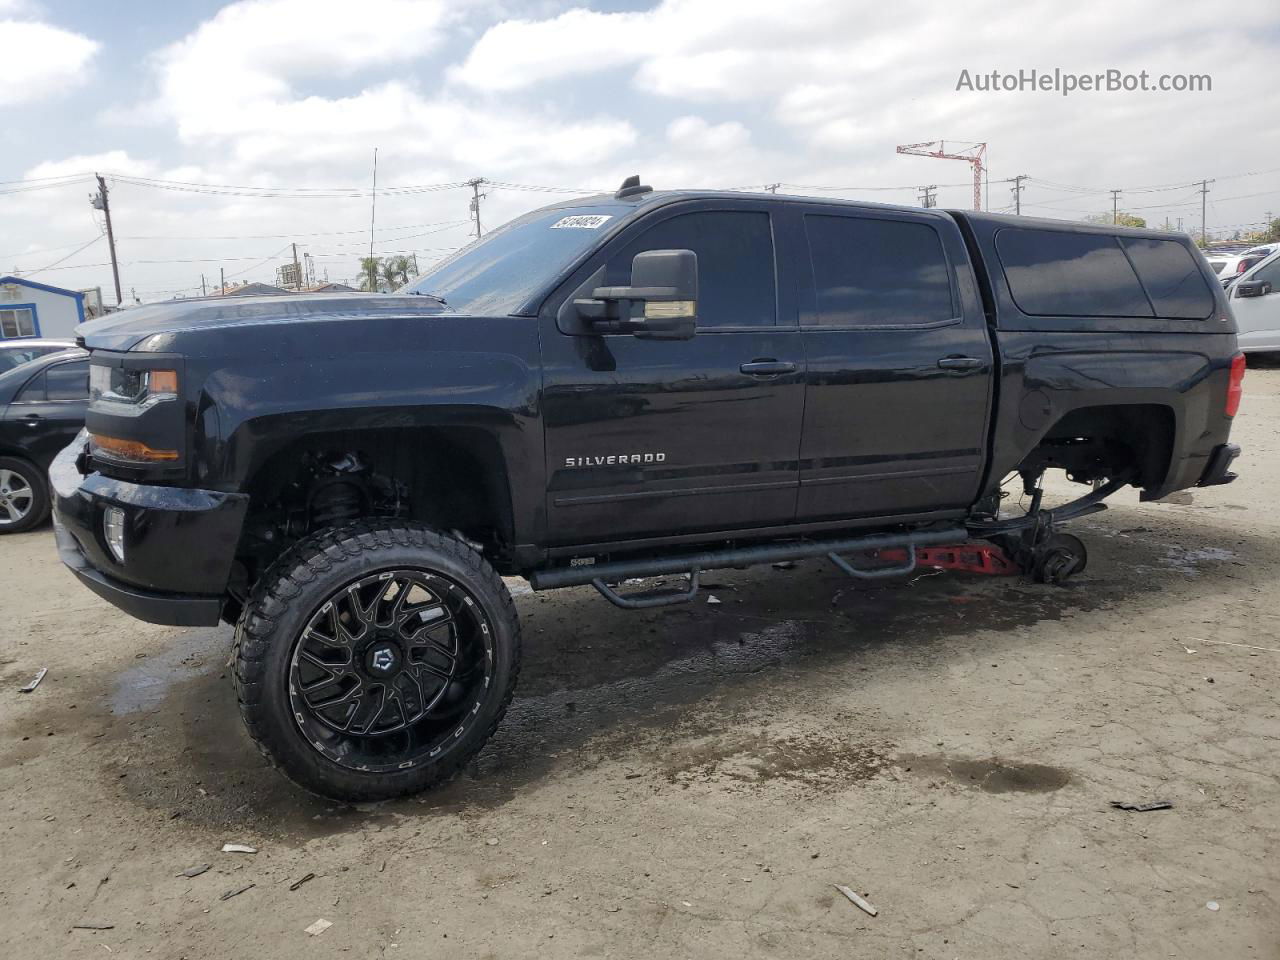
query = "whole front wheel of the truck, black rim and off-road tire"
(236, 520, 520, 801)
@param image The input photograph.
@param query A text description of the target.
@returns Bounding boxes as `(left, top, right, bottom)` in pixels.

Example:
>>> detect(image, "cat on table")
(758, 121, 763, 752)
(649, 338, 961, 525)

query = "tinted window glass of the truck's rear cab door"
(804, 215, 956, 326)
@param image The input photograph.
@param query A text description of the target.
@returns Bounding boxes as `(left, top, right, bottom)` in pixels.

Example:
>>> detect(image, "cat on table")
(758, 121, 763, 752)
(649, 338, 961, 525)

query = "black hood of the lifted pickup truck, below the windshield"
(76, 293, 448, 352)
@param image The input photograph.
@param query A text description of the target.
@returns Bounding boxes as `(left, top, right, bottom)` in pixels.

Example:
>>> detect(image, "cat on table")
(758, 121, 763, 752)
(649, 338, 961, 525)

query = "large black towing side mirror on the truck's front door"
(573, 250, 698, 340)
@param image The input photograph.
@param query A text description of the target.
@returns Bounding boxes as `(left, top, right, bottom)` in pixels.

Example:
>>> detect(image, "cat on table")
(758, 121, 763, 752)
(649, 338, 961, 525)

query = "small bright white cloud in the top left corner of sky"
(0, 18, 99, 105)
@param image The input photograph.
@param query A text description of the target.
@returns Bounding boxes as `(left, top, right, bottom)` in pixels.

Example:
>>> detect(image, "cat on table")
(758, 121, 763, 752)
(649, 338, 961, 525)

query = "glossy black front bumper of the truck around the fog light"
(49, 434, 248, 626)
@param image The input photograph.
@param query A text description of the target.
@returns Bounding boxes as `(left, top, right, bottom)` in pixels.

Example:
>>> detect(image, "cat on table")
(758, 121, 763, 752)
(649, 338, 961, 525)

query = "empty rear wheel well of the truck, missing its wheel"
(1018, 403, 1175, 489)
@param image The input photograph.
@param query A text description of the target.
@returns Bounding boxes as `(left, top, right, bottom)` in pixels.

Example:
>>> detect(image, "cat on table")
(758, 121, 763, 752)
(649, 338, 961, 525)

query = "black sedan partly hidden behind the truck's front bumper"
(0, 348, 88, 534)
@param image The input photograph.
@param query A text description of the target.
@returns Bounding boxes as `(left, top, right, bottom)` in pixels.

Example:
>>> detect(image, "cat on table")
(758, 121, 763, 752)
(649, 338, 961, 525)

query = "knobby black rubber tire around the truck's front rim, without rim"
(234, 520, 521, 803)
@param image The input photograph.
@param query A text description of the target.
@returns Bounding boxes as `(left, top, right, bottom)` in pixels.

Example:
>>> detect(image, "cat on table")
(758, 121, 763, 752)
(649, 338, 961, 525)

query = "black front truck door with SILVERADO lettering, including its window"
(540, 200, 804, 545)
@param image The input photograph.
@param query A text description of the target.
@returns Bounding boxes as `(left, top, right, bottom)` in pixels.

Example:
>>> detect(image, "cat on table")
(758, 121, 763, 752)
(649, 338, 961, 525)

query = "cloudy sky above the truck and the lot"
(0, 0, 1280, 303)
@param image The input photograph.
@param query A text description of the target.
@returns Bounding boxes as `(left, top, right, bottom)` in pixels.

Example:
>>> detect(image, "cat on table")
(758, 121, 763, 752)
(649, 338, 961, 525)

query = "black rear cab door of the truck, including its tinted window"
(795, 206, 992, 521)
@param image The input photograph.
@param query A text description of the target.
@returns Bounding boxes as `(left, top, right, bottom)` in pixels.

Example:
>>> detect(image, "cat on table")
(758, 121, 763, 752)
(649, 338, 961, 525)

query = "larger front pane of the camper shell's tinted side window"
(996, 227, 1155, 317)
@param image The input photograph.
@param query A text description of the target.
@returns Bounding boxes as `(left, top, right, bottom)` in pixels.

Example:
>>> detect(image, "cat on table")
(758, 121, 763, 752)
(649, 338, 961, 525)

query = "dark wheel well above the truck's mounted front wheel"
(237, 428, 513, 582)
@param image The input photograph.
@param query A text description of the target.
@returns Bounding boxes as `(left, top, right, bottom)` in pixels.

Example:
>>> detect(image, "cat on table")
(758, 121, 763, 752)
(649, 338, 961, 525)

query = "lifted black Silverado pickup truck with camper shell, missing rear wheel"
(50, 179, 1244, 800)
